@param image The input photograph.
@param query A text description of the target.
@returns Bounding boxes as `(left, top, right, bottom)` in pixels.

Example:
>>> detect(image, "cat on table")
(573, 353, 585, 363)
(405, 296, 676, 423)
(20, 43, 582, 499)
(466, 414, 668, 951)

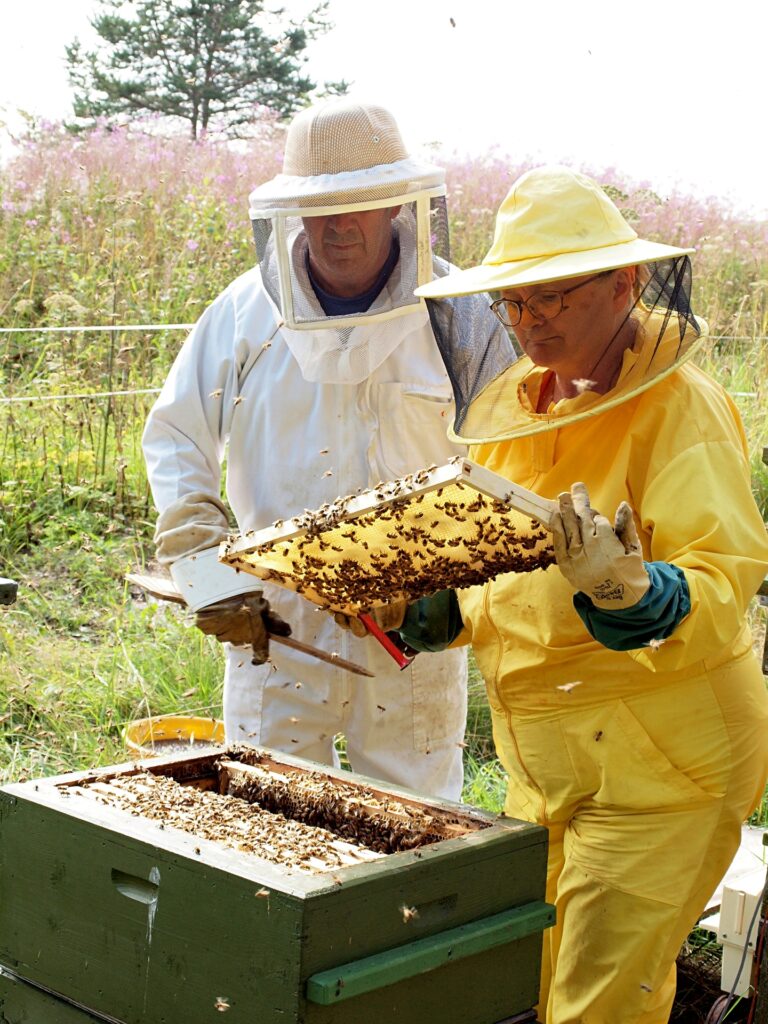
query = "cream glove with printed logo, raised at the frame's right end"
(551, 483, 650, 611)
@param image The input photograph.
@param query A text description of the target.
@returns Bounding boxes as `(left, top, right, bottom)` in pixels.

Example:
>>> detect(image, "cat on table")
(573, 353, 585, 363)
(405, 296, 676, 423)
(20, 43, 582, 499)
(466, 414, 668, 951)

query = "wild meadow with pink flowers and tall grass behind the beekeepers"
(0, 117, 768, 820)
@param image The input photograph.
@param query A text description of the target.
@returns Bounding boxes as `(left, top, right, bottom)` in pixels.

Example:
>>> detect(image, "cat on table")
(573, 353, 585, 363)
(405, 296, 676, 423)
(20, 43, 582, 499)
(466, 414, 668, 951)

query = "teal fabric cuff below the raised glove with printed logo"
(573, 562, 690, 650)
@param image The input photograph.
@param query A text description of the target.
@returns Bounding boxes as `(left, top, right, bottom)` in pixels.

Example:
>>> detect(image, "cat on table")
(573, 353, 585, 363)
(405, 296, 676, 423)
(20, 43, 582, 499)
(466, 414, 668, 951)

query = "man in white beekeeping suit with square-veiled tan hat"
(143, 99, 515, 799)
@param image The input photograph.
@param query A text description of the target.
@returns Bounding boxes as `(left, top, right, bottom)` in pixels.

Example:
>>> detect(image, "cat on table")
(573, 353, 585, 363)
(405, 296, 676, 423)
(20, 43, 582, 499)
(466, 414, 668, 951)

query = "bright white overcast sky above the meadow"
(0, 0, 768, 217)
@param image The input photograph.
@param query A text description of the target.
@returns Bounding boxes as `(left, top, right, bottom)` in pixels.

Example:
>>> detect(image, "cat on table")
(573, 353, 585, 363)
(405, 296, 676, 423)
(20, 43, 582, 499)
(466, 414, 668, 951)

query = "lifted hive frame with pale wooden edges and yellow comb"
(219, 456, 556, 614)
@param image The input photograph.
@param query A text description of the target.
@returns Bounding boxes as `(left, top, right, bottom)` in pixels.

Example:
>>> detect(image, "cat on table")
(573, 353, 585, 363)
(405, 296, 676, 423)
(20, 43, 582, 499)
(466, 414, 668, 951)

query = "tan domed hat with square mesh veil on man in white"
(250, 98, 450, 345)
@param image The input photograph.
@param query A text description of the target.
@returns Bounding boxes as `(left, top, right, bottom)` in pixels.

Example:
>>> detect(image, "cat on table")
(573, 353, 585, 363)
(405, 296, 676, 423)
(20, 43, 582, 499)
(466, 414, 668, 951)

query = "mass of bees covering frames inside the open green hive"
(63, 746, 484, 876)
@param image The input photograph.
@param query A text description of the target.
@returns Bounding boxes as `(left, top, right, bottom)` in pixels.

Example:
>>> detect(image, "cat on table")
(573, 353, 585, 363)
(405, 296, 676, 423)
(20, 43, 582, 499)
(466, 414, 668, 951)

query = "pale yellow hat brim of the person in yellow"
(416, 239, 694, 299)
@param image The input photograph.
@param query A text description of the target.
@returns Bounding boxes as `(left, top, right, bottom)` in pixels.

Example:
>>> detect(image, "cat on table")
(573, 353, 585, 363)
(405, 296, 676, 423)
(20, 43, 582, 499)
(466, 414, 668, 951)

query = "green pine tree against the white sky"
(67, 0, 346, 138)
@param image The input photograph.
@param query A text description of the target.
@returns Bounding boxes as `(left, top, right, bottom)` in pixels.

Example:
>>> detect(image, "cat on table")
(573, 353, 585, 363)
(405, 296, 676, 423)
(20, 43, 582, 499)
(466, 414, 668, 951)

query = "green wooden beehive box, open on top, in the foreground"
(0, 748, 554, 1024)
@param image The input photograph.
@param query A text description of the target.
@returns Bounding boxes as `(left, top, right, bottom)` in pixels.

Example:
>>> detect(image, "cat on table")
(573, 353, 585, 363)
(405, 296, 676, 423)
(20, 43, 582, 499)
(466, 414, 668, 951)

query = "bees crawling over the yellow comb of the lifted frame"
(225, 458, 555, 614)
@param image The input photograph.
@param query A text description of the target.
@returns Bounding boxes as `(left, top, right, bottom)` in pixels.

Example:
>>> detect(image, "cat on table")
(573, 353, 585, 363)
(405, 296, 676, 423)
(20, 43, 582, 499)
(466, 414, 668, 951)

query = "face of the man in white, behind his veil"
(303, 207, 400, 298)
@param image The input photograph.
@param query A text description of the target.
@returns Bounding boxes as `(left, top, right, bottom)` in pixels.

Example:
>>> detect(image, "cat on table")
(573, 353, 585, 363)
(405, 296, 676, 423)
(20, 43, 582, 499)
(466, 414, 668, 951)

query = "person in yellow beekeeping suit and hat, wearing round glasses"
(411, 168, 768, 1024)
